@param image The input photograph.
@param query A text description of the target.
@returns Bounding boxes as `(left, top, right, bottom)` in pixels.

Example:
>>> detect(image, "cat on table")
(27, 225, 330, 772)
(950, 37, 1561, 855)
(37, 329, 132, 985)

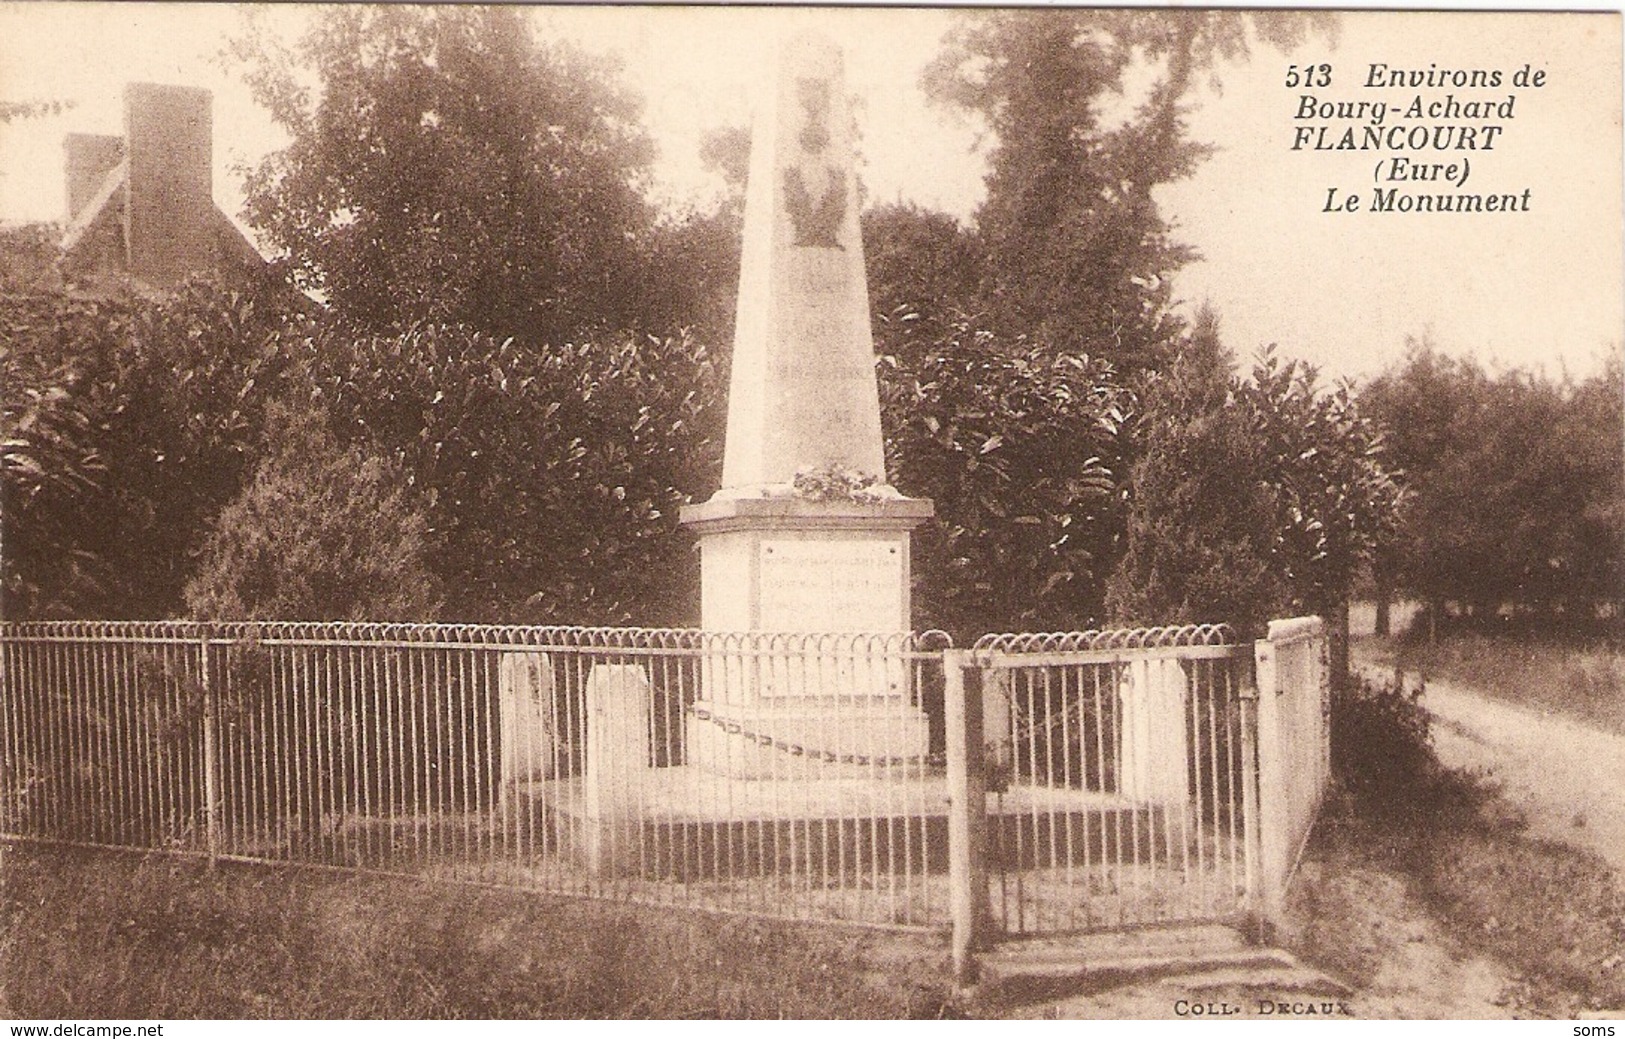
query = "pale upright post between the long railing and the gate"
(943, 649, 988, 985)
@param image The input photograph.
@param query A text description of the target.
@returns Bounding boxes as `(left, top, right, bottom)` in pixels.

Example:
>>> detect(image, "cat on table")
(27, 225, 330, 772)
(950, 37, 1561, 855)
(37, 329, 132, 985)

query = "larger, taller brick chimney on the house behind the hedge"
(123, 83, 216, 288)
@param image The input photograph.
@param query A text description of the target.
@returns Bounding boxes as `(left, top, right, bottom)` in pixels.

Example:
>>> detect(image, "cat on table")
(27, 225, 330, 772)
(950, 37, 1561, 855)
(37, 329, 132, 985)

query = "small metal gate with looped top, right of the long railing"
(975, 628, 1250, 935)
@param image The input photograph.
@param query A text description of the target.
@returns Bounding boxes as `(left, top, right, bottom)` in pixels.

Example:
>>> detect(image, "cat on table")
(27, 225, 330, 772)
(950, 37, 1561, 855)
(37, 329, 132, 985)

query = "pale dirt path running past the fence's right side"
(1358, 663, 1625, 878)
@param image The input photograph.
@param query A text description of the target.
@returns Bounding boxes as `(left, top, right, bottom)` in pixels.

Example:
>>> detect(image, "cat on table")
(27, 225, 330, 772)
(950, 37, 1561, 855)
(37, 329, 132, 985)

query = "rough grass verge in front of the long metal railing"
(0, 844, 951, 1019)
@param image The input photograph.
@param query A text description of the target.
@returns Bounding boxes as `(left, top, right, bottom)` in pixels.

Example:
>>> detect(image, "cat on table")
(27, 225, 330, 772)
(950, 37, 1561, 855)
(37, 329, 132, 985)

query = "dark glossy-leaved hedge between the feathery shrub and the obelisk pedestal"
(301, 325, 720, 624)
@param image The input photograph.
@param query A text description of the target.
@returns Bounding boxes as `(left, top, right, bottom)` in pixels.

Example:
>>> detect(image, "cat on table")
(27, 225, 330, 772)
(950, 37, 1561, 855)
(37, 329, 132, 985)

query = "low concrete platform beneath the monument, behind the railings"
(517, 766, 1185, 881)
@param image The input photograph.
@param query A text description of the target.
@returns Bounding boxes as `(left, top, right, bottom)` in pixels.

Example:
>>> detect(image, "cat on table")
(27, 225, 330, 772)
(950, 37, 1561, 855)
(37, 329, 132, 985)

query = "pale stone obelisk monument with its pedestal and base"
(683, 34, 931, 777)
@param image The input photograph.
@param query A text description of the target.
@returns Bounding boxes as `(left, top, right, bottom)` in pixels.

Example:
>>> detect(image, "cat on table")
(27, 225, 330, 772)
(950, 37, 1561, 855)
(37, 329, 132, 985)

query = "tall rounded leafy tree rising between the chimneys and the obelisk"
(237, 5, 653, 345)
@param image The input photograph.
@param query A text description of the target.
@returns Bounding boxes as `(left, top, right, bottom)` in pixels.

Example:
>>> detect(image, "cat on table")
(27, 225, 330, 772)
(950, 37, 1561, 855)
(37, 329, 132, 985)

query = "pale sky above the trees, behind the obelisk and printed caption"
(0, 2, 1625, 386)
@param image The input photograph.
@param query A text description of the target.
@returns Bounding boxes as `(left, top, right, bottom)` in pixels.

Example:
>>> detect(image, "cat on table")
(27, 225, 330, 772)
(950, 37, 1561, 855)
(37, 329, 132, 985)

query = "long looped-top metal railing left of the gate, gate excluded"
(0, 623, 947, 925)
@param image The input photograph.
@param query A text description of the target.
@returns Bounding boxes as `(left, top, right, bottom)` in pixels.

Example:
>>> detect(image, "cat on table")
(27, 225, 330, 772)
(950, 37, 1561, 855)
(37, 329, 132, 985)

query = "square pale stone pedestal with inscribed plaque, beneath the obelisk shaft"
(683, 498, 931, 777)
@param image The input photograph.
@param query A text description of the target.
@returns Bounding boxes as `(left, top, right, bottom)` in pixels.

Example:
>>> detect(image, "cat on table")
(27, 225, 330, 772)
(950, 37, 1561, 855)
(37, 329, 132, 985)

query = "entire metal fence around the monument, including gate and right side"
(0, 618, 1329, 953)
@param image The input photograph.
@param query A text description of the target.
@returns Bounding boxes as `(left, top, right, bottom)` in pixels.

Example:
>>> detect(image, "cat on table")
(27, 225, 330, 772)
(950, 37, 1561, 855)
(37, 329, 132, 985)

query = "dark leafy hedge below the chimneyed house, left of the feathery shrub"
(0, 281, 299, 618)
